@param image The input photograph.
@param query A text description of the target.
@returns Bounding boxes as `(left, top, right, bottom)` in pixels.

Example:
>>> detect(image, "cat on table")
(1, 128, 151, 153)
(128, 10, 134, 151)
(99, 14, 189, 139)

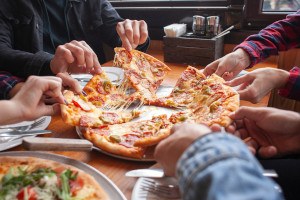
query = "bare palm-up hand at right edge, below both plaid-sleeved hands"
(230, 107, 300, 158)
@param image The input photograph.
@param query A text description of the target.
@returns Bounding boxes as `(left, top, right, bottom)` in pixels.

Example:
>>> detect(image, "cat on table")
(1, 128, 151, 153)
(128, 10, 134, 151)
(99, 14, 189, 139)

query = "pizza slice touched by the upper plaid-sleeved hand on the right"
(147, 66, 206, 108)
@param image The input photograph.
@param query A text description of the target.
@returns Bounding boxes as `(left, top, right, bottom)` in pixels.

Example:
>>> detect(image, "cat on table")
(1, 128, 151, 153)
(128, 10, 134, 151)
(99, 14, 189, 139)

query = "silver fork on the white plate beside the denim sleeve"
(141, 179, 181, 199)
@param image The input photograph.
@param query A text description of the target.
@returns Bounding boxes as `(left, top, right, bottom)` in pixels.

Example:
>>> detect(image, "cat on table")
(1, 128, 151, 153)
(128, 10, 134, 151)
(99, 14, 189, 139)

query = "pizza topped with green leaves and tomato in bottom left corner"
(0, 156, 108, 200)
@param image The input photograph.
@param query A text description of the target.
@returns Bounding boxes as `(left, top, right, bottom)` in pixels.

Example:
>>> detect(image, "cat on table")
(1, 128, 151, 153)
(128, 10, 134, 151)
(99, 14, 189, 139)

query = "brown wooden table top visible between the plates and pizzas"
(7, 51, 276, 199)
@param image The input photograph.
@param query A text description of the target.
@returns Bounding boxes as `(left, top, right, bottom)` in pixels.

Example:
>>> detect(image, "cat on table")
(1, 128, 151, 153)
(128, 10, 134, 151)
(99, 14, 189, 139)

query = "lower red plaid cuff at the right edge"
(278, 67, 300, 100)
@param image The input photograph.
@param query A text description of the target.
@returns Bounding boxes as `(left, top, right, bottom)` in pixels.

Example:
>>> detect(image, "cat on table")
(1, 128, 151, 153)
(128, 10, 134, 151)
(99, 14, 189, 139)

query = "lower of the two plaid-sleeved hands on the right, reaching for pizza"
(226, 68, 289, 103)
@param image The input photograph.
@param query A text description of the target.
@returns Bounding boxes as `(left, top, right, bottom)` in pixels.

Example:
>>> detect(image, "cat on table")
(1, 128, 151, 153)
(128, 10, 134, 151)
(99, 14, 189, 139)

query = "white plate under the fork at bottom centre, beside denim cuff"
(131, 177, 180, 200)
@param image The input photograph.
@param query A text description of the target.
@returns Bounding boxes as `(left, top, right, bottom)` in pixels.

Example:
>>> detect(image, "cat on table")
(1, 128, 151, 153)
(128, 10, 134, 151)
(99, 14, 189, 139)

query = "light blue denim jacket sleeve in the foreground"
(177, 133, 283, 200)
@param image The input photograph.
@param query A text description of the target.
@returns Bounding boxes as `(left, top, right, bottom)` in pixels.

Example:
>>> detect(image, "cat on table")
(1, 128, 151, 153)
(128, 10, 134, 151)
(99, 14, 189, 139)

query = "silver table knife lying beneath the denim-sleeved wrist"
(125, 169, 278, 178)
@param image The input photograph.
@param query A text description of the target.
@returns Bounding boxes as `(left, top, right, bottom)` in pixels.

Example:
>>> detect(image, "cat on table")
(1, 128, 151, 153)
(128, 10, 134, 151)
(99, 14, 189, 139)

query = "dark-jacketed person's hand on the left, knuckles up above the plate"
(50, 40, 102, 74)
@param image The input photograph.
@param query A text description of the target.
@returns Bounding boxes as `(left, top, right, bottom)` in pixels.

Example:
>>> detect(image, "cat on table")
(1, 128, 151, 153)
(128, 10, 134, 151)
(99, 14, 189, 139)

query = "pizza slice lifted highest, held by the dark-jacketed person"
(114, 47, 171, 101)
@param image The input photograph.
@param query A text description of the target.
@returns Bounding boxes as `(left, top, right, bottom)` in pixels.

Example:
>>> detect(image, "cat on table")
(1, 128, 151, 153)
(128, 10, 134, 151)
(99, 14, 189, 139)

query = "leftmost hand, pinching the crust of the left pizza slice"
(11, 76, 64, 121)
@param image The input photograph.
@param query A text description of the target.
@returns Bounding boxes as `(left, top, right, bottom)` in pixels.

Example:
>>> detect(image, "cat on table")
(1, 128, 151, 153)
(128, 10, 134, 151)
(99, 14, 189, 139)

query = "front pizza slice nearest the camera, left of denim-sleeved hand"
(82, 115, 172, 158)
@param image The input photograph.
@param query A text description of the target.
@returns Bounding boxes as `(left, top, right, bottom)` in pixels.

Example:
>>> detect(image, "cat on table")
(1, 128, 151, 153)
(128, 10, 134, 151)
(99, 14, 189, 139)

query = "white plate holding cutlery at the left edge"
(0, 116, 51, 151)
